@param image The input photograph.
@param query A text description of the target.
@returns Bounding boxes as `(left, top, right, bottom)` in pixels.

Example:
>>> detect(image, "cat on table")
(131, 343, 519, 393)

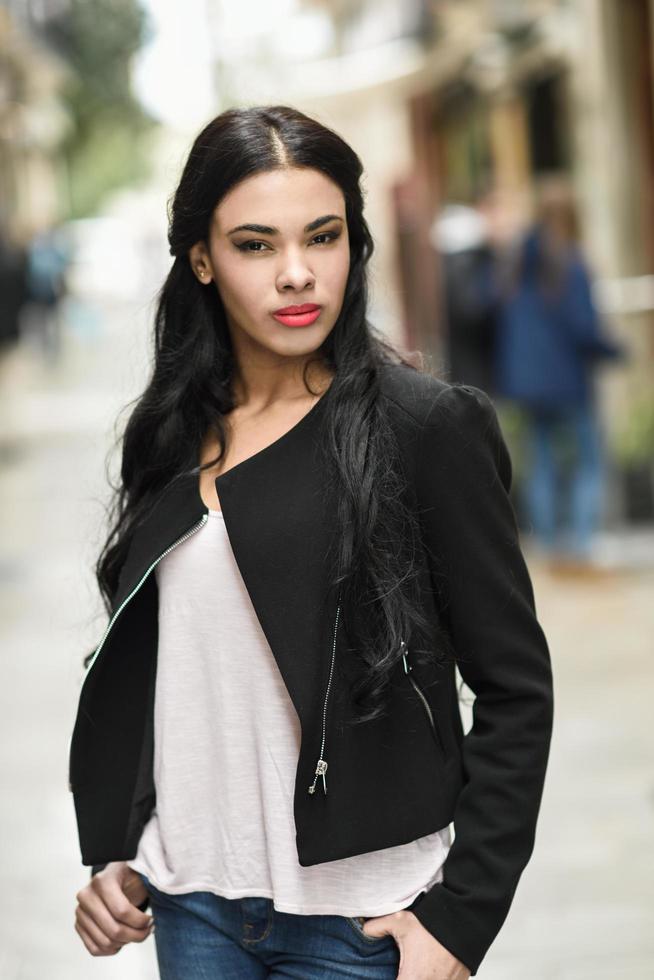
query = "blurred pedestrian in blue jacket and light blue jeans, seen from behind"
(495, 178, 624, 570)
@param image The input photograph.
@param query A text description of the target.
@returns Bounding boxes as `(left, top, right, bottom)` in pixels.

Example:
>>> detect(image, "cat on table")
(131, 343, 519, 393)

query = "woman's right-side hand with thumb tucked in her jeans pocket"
(363, 909, 470, 980)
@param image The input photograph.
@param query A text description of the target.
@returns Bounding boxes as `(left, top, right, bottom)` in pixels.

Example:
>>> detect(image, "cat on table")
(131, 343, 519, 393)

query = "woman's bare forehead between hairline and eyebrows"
(213, 167, 345, 232)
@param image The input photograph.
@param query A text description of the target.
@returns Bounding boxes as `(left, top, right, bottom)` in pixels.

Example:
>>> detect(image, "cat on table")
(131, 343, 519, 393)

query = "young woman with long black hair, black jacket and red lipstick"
(70, 106, 552, 980)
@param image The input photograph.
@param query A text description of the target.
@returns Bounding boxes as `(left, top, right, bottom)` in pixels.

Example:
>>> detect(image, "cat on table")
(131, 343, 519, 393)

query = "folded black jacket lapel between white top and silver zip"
(216, 399, 336, 724)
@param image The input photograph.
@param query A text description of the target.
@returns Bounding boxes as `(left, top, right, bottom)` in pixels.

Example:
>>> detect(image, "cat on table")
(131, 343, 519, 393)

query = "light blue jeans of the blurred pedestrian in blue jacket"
(524, 404, 604, 559)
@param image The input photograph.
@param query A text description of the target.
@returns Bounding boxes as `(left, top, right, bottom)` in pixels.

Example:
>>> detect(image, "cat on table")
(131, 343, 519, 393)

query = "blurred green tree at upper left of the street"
(47, 0, 157, 217)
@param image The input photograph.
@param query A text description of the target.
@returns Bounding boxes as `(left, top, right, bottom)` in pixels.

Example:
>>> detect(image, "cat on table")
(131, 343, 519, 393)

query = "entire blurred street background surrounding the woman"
(0, 0, 654, 980)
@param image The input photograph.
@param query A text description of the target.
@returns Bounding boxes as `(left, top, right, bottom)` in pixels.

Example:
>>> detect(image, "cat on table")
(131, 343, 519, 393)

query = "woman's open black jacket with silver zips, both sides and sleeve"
(70, 365, 553, 974)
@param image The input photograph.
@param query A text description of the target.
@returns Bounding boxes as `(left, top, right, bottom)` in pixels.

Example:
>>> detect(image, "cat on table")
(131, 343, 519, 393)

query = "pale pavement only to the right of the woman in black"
(479, 552, 654, 980)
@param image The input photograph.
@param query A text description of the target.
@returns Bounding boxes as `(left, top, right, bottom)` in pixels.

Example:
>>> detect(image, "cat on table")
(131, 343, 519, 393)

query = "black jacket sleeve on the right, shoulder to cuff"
(412, 385, 553, 975)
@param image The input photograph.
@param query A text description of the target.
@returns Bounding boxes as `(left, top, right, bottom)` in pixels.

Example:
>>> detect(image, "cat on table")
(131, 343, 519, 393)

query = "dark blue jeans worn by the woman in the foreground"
(139, 873, 400, 980)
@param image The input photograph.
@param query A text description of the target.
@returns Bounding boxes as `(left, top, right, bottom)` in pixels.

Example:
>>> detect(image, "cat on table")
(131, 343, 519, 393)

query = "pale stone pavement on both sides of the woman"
(0, 310, 654, 980)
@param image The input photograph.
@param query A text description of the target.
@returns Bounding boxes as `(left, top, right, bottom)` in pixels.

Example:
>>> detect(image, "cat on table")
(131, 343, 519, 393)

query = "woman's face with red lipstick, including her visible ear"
(189, 168, 350, 366)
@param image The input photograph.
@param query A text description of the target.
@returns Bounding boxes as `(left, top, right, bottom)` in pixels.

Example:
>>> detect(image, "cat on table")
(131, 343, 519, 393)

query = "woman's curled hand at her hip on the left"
(75, 861, 154, 956)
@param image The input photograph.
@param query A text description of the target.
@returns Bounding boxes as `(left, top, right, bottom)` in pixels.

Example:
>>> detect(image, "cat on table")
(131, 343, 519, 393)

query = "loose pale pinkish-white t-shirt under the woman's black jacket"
(128, 510, 451, 917)
